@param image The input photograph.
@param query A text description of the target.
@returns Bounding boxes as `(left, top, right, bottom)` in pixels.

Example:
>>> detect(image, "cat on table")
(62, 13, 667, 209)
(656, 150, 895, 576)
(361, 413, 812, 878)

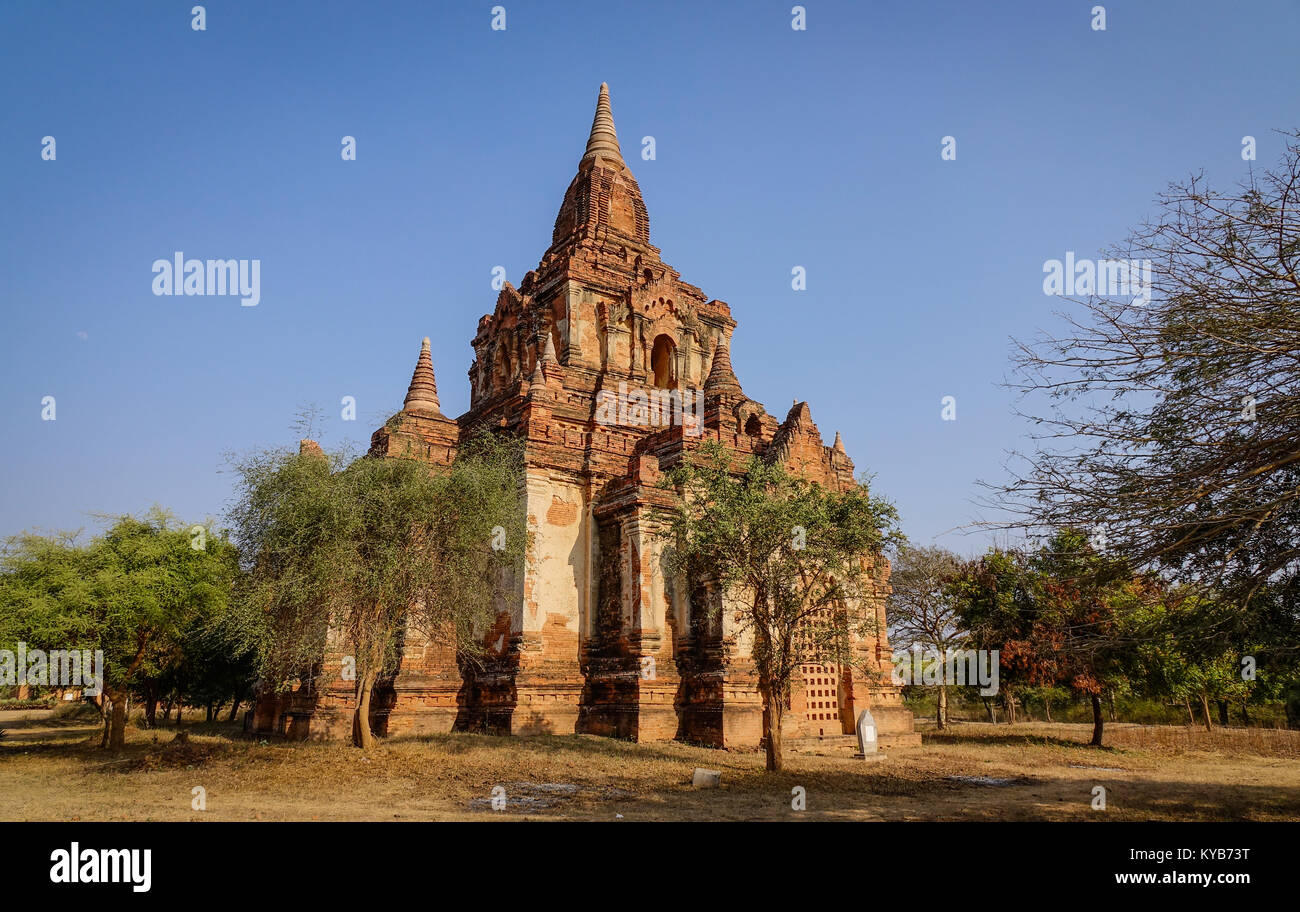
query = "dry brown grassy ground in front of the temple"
(0, 713, 1300, 821)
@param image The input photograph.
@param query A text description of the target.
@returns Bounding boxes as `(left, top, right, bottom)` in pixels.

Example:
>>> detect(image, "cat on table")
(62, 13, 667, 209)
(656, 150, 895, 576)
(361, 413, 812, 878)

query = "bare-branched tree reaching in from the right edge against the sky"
(992, 133, 1300, 646)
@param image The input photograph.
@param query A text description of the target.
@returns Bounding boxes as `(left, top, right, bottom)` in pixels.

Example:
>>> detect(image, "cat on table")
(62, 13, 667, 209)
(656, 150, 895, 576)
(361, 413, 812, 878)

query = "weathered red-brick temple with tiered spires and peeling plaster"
(250, 84, 913, 747)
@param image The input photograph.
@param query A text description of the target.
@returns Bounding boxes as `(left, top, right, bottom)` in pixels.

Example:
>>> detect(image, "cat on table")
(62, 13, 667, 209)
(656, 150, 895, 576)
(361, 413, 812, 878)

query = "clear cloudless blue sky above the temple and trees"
(0, 0, 1300, 553)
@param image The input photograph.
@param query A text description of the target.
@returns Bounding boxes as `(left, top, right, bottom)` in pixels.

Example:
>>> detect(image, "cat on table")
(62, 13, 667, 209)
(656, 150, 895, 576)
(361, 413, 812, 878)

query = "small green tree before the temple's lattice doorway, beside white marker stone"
(664, 442, 898, 770)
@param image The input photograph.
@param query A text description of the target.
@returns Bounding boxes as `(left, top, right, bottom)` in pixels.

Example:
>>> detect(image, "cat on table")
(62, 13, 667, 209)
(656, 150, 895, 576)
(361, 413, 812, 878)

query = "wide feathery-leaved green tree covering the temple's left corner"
(231, 434, 528, 748)
